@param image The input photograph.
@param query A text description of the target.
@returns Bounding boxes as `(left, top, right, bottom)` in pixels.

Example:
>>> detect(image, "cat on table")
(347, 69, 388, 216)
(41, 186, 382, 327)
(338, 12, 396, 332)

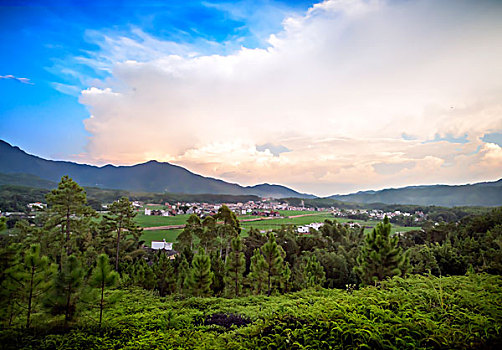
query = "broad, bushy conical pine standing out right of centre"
(354, 217, 408, 284)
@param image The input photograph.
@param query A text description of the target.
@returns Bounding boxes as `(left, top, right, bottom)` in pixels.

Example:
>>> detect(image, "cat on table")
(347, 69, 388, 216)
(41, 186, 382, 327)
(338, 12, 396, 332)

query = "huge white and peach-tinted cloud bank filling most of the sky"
(76, 0, 502, 195)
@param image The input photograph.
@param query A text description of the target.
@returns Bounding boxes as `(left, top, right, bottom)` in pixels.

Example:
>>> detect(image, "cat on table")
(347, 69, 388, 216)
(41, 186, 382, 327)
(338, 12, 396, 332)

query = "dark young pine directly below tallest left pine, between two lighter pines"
(45, 255, 84, 325)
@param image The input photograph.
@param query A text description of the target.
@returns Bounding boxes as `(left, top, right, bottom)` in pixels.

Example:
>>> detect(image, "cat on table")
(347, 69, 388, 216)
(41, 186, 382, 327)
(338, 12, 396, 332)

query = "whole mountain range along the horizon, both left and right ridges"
(0, 140, 502, 207)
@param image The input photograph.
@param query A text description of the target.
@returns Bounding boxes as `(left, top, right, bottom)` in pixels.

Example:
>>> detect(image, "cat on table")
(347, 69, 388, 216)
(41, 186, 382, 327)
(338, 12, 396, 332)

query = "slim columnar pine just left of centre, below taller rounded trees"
(225, 236, 246, 297)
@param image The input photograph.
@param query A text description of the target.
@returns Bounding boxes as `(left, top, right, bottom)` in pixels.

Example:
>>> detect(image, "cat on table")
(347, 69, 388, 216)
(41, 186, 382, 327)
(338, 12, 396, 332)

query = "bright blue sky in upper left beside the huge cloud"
(0, 0, 313, 159)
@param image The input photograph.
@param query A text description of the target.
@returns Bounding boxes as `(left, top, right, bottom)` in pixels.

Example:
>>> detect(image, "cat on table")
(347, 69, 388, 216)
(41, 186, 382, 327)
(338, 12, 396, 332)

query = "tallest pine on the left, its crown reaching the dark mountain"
(46, 175, 96, 258)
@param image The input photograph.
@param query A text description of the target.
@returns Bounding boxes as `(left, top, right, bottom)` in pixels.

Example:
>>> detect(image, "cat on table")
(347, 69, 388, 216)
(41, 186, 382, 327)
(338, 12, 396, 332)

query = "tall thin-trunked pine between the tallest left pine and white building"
(105, 197, 142, 272)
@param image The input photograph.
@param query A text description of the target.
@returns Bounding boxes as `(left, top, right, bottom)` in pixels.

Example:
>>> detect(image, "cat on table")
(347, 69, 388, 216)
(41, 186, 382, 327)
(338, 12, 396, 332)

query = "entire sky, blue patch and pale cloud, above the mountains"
(0, 0, 502, 196)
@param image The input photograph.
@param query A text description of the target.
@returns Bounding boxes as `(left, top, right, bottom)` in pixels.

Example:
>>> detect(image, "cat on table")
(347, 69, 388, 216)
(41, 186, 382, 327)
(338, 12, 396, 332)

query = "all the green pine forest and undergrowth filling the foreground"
(0, 177, 502, 349)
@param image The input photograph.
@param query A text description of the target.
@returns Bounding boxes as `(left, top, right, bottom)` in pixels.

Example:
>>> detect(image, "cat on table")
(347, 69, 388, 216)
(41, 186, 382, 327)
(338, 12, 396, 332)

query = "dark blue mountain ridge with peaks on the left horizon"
(0, 140, 315, 198)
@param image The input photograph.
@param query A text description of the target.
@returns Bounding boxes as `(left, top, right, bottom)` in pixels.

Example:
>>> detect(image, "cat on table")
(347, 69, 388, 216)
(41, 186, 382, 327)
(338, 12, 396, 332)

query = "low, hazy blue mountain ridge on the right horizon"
(328, 179, 502, 207)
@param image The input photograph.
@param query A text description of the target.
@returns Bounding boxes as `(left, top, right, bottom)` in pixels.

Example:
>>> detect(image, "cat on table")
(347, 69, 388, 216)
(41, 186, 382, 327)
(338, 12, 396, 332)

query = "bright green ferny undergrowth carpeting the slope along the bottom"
(0, 274, 502, 349)
